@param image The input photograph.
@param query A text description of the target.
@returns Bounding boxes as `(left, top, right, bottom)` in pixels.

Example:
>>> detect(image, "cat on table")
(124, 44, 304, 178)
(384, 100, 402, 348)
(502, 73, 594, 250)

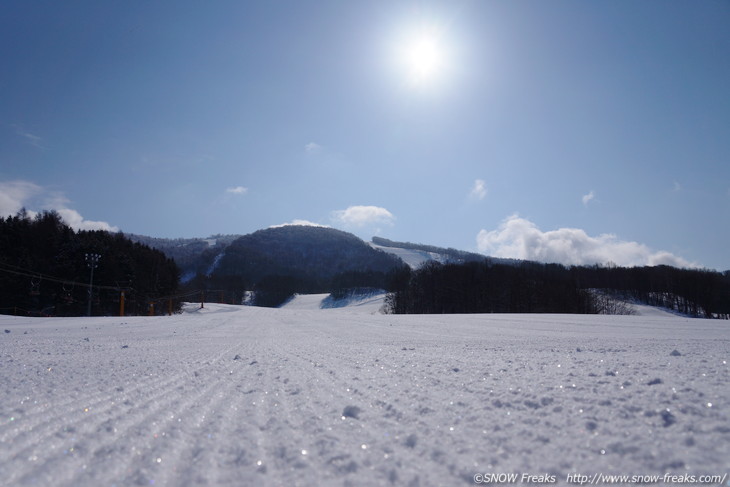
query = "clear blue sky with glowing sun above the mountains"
(0, 0, 730, 270)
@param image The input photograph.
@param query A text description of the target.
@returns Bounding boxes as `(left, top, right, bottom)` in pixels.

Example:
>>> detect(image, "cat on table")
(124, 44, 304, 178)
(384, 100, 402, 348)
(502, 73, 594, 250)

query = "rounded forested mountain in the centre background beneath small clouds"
(130, 225, 403, 306)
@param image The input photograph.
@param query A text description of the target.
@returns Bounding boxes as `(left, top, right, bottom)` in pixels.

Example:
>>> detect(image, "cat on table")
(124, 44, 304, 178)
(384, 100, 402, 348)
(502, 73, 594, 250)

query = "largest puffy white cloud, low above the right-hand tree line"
(477, 215, 698, 267)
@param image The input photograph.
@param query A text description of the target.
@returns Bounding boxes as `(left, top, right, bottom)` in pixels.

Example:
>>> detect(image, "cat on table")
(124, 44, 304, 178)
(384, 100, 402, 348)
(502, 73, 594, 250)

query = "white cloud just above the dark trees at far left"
(0, 181, 119, 232)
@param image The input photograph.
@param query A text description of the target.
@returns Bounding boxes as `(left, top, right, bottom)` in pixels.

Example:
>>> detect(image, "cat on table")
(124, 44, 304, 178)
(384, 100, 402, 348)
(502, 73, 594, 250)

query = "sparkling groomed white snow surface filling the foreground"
(0, 303, 730, 486)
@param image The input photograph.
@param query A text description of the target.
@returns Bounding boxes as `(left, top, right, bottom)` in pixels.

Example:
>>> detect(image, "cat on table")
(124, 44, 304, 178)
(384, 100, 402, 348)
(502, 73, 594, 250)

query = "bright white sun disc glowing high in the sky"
(400, 30, 446, 85)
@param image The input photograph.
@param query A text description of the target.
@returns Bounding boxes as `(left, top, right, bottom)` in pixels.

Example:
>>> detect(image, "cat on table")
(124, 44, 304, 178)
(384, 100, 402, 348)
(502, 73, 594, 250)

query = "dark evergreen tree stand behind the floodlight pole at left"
(0, 210, 180, 316)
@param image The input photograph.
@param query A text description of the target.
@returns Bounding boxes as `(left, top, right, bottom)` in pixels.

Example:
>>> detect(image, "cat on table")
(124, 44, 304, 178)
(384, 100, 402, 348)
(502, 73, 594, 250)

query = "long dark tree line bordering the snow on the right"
(387, 260, 730, 318)
